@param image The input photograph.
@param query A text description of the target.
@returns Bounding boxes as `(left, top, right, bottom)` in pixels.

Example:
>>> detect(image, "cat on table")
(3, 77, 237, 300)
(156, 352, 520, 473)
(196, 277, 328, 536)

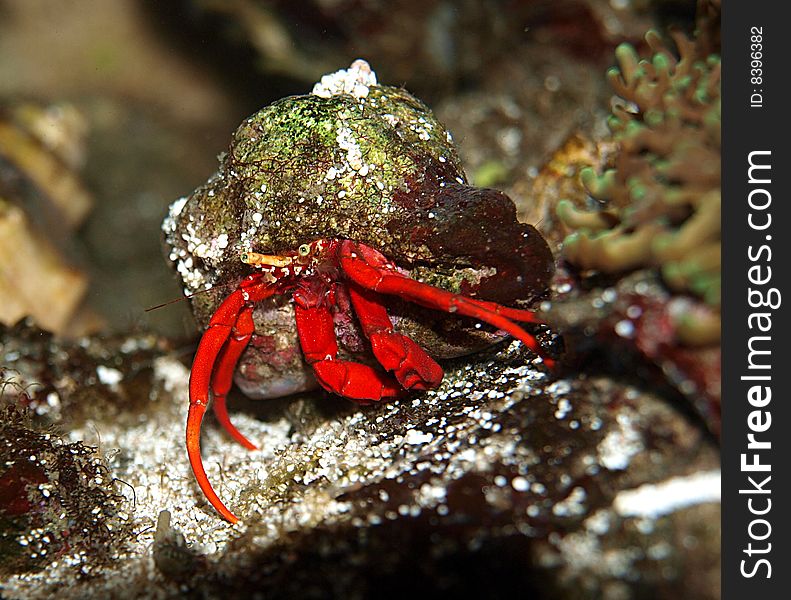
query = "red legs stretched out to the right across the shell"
(338, 241, 555, 368)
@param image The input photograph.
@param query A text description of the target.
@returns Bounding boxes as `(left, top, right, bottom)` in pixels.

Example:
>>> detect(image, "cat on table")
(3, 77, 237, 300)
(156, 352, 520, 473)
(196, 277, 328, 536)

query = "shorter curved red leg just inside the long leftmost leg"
(211, 306, 256, 450)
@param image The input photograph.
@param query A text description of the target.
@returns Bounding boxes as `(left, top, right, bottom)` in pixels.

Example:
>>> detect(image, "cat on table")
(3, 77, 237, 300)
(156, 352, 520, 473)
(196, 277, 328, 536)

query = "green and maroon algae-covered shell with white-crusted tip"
(163, 61, 553, 398)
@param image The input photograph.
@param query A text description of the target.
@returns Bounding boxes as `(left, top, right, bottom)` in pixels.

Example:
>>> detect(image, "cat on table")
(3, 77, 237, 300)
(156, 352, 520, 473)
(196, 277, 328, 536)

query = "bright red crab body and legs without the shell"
(187, 239, 553, 522)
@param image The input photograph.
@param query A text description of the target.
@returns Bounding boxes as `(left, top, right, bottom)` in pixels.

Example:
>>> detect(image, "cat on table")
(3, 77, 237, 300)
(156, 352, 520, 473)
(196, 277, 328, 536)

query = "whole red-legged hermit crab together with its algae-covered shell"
(163, 60, 554, 522)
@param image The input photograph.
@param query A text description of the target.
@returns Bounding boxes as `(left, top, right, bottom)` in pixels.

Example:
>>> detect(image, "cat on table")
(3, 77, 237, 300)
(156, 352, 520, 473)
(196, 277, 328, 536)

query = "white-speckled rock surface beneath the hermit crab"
(2, 324, 719, 598)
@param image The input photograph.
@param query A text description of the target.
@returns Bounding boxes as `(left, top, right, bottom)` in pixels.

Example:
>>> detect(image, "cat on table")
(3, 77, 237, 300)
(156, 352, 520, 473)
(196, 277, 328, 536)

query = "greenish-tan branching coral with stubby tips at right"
(557, 18, 721, 343)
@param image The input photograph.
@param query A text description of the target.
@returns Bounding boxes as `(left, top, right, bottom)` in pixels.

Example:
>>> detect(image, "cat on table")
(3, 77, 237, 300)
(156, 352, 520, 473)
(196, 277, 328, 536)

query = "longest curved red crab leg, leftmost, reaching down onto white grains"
(187, 274, 279, 523)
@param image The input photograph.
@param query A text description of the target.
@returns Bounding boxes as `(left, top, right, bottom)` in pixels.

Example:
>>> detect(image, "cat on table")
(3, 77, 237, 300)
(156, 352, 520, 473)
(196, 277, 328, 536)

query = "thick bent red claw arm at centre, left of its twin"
(295, 303, 401, 404)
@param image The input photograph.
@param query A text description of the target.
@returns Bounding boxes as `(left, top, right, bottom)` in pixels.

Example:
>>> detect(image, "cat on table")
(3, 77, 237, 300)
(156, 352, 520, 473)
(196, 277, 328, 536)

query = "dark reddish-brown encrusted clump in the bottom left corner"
(0, 398, 131, 575)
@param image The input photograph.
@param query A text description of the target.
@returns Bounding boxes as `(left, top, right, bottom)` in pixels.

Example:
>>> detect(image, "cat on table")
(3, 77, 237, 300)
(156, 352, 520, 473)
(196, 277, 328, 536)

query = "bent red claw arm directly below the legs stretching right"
(348, 283, 444, 390)
